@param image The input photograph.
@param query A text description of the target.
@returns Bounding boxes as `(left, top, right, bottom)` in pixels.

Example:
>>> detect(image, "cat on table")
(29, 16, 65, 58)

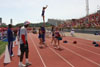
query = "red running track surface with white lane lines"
(0, 33, 100, 67)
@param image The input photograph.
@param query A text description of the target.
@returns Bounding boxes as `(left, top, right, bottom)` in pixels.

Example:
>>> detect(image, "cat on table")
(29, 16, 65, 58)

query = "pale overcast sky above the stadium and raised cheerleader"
(0, 0, 100, 24)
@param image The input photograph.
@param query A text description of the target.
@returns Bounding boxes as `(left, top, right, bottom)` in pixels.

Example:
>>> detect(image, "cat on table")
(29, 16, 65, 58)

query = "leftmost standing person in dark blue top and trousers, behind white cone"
(7, 24, 14, 56)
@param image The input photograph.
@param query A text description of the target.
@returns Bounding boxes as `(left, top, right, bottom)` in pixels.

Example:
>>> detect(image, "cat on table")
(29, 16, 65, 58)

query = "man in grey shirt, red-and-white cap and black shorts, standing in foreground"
(19, 21, 31, 67)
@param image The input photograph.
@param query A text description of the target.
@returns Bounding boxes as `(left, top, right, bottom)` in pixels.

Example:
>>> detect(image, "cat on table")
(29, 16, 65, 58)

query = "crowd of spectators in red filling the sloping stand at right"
(59, 12, 100, 29)
